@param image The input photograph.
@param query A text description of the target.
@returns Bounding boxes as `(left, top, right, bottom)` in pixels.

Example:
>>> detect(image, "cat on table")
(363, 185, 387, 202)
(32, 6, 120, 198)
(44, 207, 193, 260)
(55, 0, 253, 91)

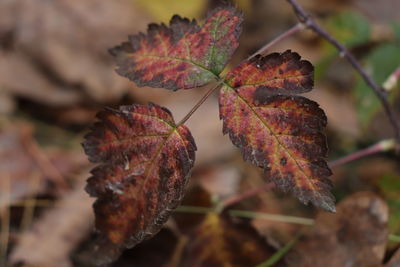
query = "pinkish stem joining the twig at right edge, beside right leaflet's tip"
(329, 139, 396, 168)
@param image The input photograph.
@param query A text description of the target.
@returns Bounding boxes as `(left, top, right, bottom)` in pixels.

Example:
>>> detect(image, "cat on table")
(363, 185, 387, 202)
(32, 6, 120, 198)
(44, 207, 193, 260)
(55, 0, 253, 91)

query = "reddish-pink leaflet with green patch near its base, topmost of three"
(110, 7, 242, 90)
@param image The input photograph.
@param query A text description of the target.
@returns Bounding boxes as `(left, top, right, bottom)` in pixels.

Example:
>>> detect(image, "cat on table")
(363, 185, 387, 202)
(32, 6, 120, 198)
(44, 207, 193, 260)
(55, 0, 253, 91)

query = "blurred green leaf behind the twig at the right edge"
(354, 44, 400, 127)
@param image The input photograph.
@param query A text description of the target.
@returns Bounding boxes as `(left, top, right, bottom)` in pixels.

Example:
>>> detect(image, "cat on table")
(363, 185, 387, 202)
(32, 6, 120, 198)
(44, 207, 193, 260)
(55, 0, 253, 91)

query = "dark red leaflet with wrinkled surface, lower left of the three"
(83, 104, 196, 263)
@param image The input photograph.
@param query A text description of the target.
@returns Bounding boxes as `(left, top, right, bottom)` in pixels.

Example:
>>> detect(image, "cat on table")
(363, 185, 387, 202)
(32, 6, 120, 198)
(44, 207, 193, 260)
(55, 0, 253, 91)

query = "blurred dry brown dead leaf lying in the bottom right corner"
(285, 192, 390, 267)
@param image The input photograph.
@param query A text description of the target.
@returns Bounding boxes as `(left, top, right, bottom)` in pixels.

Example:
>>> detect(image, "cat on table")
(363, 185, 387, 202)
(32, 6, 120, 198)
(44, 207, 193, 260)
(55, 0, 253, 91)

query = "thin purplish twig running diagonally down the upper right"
(286, 0, 400, 143)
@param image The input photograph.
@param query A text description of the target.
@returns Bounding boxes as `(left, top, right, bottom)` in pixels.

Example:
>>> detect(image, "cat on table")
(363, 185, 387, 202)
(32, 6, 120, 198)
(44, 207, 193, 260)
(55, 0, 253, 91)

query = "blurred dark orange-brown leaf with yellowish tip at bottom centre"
(179, 214, 275, 267)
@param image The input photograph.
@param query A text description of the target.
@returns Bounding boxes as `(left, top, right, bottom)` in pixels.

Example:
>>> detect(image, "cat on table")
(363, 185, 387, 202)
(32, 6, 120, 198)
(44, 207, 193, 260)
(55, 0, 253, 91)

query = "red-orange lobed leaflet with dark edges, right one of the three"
(219, 50, 335, 211)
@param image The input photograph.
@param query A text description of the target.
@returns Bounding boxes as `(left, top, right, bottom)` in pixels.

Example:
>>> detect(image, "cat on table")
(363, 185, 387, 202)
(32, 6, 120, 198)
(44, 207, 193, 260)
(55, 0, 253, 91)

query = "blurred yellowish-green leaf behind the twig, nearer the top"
(315, 11, 371, 80)
